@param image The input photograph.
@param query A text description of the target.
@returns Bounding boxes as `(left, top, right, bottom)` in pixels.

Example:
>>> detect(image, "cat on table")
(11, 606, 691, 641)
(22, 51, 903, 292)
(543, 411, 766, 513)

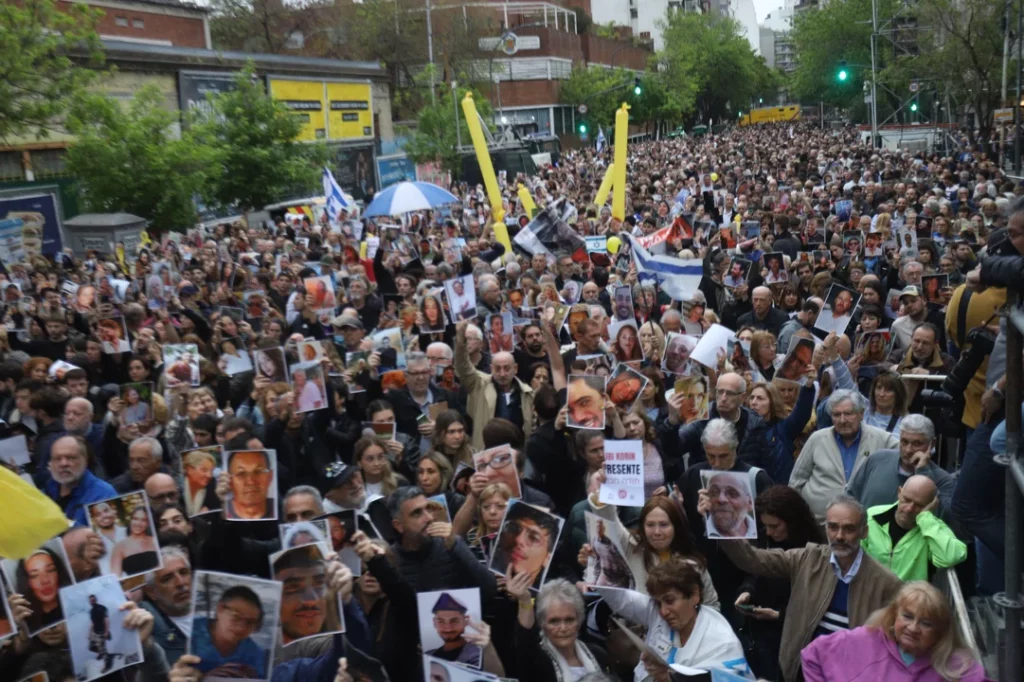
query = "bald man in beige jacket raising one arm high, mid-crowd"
(455, 322, 534, 452)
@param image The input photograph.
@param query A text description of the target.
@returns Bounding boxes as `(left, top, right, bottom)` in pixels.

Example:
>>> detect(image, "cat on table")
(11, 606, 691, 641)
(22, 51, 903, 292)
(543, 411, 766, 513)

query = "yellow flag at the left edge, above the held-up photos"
(0, 467, 70, 559)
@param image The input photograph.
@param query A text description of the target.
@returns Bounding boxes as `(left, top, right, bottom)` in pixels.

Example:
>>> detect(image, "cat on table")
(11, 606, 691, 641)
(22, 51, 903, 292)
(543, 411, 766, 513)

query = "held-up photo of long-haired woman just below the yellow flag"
(4, 540, 72, 637)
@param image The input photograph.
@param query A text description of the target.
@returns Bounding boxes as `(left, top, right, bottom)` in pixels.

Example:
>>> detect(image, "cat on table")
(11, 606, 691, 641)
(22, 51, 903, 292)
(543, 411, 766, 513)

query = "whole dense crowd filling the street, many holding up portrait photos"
(0, 124, 1024, 682)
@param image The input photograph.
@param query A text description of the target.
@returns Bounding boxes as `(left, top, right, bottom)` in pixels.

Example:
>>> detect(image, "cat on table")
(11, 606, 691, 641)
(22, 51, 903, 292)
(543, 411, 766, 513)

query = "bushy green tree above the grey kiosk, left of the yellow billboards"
(67, 86, 217, 231)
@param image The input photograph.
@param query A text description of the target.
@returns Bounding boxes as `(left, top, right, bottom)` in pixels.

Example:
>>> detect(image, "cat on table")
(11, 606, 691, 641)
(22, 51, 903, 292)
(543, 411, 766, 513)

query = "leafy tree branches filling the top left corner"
(0, 0, 102, 140)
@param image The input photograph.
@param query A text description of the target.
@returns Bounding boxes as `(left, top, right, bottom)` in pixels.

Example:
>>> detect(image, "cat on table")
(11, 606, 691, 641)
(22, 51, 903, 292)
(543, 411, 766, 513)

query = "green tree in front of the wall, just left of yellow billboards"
(191, 65, 328, 211)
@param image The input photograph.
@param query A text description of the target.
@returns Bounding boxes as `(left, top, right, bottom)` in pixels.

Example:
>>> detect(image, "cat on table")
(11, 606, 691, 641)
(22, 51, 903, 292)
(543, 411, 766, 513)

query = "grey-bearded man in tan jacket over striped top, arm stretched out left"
(719, 495, 902, 682)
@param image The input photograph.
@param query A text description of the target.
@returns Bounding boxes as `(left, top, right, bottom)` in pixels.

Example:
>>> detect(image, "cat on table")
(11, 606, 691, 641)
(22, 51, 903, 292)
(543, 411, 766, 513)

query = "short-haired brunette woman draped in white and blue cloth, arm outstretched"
(594, 558, 754, 682)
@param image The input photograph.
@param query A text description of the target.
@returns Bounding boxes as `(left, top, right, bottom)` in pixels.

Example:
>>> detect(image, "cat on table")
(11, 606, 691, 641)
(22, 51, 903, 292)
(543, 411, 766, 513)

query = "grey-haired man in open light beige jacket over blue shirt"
(790, 390, 899, 522)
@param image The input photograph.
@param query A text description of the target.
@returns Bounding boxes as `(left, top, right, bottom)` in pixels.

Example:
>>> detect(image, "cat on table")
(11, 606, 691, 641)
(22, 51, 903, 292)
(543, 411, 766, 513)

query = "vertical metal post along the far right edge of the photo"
(993, 288, 1024, 681)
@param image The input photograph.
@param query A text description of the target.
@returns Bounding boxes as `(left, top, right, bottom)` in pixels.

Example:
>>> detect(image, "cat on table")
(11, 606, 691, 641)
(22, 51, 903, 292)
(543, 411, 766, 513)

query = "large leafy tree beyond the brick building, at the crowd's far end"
(657, 12, 778, 121)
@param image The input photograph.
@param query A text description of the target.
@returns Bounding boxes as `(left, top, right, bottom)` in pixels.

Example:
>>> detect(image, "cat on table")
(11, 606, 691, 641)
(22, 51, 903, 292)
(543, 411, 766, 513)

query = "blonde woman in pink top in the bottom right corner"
(801, 582, 987, 682)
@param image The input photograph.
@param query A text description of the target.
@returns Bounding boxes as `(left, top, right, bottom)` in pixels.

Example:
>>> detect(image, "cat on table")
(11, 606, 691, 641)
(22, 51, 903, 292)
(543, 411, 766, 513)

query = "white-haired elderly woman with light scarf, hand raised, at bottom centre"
(506, 573, 608, 682)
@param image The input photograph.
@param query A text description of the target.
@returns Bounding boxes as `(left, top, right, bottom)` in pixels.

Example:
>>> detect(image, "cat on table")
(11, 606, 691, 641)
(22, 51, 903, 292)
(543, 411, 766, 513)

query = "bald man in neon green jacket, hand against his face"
(861, 475, 967, 581)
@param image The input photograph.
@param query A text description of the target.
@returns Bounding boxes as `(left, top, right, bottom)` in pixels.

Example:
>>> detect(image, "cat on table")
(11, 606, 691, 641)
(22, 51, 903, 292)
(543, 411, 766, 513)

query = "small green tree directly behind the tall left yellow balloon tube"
(402, 67, 493, 177)
